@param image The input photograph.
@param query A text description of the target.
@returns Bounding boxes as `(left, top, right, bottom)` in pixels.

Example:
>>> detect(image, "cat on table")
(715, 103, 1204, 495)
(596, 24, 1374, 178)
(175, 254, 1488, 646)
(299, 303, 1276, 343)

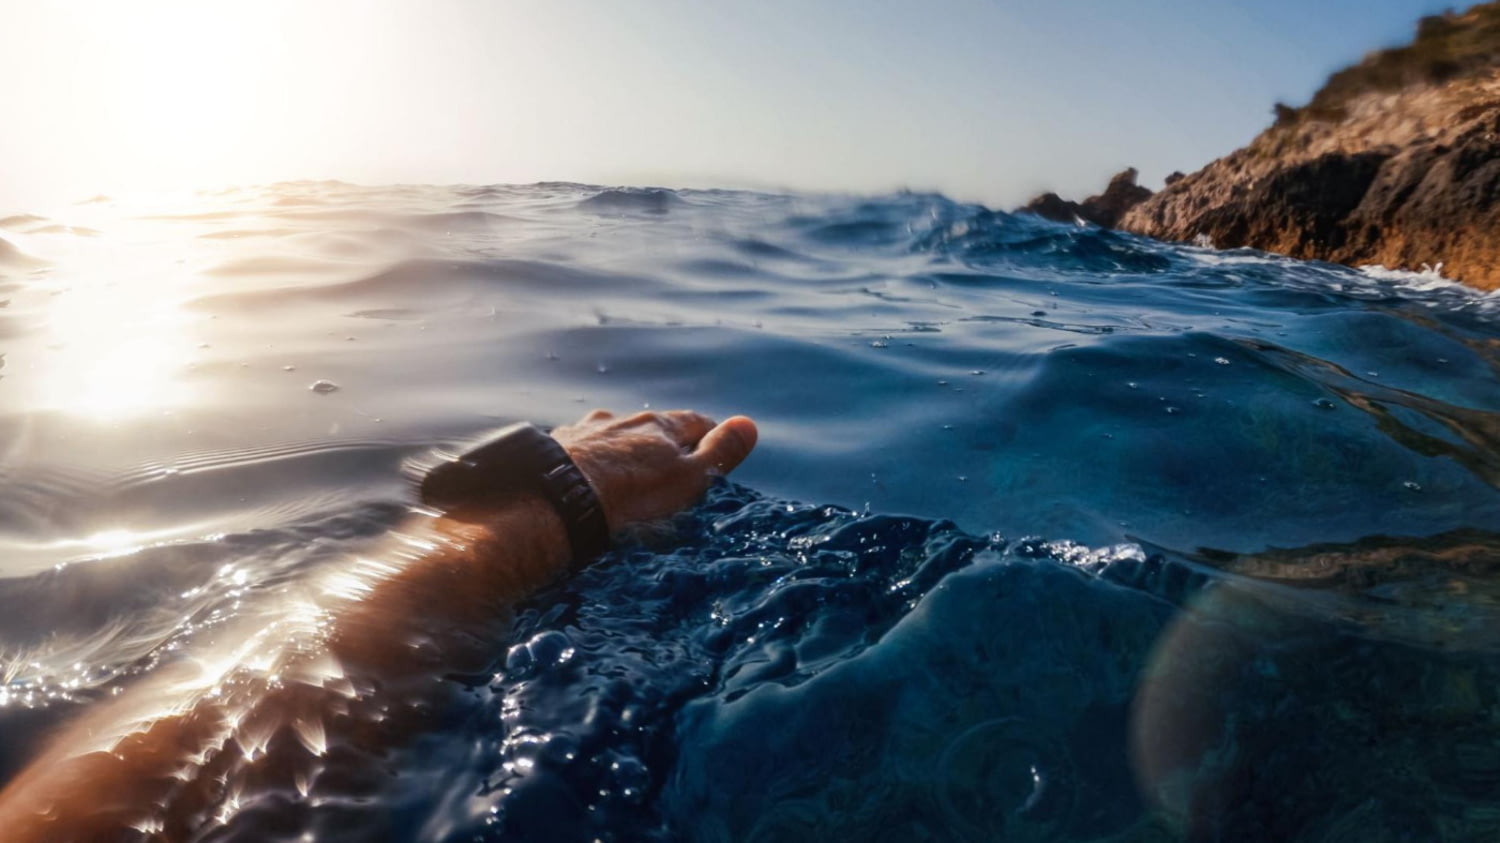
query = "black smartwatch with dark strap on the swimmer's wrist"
(420, 422, 609, 566)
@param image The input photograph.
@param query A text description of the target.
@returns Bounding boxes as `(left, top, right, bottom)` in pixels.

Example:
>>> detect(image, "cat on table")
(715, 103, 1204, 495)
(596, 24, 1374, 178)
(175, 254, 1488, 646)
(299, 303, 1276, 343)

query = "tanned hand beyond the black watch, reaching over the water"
(552, 410, 758, 531)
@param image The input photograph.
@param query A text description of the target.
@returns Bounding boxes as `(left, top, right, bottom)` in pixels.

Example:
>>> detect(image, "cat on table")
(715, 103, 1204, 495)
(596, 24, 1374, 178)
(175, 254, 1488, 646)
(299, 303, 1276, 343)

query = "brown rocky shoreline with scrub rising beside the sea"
(1020, 2, 1500, 290)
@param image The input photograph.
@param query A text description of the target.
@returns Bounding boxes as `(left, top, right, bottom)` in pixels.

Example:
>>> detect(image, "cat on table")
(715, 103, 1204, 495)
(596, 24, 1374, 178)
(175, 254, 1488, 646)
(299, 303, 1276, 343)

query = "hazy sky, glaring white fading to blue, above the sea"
(0, 0, 1451, 215)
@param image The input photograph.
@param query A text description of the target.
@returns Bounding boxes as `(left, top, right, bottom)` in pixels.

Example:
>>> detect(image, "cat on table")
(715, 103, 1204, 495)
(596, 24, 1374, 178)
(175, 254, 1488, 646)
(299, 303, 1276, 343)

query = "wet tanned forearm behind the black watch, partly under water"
(0, 501, 569, 843)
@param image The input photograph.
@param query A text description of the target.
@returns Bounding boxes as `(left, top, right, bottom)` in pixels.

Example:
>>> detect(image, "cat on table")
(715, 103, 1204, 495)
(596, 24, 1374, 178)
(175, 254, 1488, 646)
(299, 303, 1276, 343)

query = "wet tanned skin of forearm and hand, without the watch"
(0, 410, 756, 843)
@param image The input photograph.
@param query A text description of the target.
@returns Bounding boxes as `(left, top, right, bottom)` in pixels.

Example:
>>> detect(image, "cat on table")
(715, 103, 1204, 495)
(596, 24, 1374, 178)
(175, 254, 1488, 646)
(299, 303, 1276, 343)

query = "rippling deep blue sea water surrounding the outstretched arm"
(0, 183, 1500, 842)
